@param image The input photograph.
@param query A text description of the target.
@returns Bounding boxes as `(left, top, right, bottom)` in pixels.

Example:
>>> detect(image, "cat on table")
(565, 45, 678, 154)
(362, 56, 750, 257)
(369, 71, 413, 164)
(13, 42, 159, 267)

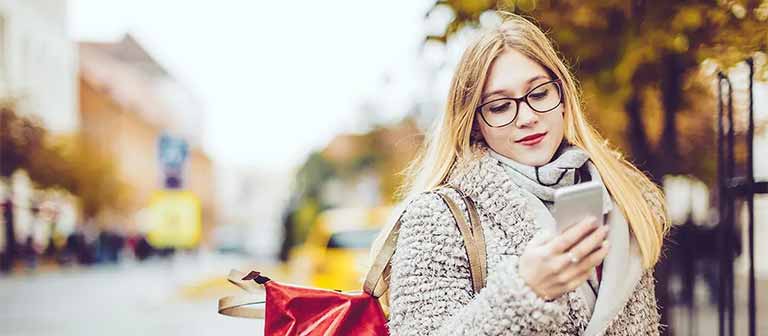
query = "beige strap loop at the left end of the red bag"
(219, 270, 267, 319)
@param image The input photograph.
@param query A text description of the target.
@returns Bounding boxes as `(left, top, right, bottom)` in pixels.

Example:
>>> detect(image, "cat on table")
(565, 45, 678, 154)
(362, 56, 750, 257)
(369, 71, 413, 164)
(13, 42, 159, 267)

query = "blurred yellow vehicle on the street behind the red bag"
(295, 207, 391, 290)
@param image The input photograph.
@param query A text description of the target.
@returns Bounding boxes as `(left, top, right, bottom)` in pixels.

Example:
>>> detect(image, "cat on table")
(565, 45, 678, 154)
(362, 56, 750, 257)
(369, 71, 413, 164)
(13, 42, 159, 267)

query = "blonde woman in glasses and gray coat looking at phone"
(374, 13, 669, 336)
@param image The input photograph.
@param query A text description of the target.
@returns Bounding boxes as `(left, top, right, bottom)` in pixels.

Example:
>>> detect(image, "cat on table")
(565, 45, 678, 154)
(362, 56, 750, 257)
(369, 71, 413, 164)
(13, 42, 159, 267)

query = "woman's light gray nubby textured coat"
(389, 147, 660, 336)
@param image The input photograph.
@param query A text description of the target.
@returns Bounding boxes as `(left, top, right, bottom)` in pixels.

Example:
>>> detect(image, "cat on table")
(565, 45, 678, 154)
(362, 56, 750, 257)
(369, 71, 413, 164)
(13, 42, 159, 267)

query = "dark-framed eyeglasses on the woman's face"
(475, 78, 563, 127)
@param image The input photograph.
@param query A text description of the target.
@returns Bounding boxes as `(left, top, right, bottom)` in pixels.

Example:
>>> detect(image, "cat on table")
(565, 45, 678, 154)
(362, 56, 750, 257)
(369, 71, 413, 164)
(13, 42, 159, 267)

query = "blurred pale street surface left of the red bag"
(0, 254, 263, 336)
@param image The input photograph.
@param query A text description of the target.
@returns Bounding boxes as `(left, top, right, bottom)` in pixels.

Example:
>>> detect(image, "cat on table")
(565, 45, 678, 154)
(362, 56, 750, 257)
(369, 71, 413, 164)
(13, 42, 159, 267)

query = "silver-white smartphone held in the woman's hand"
(552, 181, 603, 233)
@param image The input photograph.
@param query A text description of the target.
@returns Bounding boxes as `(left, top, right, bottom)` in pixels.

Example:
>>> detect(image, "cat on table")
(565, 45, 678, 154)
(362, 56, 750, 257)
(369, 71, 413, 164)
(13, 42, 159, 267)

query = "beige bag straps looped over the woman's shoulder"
(363, 184, 486, 298)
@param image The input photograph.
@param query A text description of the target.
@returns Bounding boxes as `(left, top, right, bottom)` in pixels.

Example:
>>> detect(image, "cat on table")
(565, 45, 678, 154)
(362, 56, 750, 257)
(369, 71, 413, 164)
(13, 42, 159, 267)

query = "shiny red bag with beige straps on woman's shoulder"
(219, 185, 485, 336)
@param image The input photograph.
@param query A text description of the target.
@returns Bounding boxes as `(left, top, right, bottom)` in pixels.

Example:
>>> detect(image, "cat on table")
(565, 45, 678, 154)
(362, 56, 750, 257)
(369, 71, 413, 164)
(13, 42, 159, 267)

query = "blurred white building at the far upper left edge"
(0, 0, 78, 133)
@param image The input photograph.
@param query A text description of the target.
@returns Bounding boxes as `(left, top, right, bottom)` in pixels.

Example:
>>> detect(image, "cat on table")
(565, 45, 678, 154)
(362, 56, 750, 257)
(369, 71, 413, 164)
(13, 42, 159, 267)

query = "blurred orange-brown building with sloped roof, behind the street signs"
(79, 35, 216, 243)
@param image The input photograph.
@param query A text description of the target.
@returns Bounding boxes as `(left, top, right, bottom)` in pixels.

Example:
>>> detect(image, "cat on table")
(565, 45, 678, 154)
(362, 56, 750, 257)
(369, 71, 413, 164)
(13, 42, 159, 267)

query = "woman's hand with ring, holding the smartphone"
(518, 217, 609, 300)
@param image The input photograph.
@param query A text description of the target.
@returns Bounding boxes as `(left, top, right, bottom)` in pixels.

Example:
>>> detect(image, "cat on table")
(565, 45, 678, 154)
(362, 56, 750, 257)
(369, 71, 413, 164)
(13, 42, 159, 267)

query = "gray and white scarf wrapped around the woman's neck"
(489, 141, 612, 214)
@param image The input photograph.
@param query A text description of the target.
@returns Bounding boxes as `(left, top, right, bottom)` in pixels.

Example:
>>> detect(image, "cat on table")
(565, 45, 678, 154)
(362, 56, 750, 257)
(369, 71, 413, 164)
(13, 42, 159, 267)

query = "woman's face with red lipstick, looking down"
(475, 49, 564, 166)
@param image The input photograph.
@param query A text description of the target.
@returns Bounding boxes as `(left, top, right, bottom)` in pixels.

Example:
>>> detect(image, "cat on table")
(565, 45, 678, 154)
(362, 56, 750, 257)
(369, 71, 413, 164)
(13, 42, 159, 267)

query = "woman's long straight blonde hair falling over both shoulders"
(371, 12, 669, 306)
